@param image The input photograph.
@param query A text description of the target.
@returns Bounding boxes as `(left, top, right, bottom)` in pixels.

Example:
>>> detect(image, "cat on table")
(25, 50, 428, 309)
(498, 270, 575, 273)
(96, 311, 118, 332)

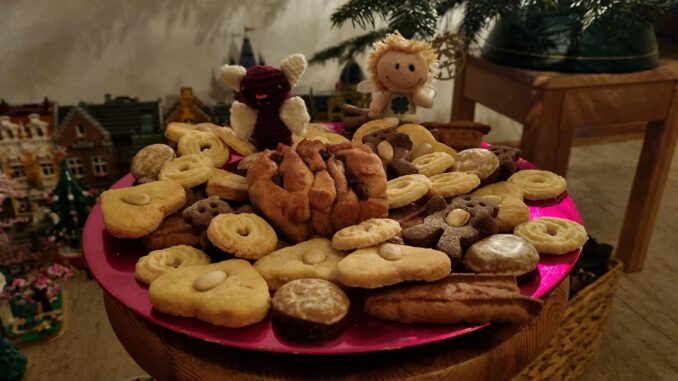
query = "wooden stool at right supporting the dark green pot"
(452, 56, 678, 272)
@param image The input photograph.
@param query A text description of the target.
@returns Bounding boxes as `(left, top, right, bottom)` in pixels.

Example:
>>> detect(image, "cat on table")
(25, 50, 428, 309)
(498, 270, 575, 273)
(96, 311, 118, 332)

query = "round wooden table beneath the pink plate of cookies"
(104, 280, 569, 381)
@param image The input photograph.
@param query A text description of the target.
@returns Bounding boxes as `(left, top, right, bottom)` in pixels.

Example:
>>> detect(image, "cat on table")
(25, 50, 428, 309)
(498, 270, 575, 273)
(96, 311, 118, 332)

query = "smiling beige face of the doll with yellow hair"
(377, 51, 429, 94)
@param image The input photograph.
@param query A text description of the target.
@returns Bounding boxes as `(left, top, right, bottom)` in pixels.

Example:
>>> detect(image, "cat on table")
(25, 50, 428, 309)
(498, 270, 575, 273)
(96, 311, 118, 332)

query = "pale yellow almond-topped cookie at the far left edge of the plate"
(101, 181, 186, 238)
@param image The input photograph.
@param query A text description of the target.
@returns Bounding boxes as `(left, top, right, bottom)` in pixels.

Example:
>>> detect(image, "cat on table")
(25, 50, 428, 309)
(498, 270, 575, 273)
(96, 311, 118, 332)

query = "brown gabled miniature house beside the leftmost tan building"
(54, 106, 119, 189)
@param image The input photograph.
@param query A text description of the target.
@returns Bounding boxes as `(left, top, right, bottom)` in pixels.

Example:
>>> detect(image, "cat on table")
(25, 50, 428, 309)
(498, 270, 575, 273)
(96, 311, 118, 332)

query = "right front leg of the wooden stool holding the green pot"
(617, 86, 678, 272)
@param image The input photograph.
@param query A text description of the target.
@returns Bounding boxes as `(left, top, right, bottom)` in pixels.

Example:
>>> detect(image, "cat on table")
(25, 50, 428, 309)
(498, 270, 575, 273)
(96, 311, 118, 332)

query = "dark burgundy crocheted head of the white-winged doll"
(240, 66, 291, 110)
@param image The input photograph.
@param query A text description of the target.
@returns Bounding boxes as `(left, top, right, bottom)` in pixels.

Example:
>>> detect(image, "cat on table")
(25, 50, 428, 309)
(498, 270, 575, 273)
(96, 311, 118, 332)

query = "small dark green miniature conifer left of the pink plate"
(43, 160, 95, 250)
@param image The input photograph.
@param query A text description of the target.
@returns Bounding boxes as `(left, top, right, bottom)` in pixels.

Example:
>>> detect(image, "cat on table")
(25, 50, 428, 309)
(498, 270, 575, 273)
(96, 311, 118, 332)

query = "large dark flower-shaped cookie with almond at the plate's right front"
(402, 195, 497, 264)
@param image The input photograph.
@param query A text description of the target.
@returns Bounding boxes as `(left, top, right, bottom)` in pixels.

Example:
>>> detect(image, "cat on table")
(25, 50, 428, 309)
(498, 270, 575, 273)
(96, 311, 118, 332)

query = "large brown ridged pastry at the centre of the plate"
(247, 140, 388, 242)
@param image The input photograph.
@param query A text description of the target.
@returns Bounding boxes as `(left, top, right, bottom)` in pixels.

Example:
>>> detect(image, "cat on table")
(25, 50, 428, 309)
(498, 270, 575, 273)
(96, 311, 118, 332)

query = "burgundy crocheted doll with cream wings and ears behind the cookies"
(221, 54, 310, 150)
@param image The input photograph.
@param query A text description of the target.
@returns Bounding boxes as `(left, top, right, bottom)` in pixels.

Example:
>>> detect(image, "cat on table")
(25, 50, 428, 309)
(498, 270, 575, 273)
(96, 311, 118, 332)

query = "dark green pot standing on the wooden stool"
(481, 12, 659, 73)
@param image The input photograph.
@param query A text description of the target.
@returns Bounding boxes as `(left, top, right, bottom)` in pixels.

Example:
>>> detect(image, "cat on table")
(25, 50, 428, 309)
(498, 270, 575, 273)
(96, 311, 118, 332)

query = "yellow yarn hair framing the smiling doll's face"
(367, 30, 436, 90)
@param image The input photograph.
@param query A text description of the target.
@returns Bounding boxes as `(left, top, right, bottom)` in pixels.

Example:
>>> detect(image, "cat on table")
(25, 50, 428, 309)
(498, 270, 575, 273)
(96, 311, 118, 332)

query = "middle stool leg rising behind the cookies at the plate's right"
(520, 90, 573, 176)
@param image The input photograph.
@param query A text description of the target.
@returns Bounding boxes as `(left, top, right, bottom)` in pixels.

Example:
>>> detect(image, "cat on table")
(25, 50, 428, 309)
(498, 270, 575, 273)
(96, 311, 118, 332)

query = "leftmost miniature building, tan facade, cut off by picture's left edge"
(0, 98, 58, 226)
